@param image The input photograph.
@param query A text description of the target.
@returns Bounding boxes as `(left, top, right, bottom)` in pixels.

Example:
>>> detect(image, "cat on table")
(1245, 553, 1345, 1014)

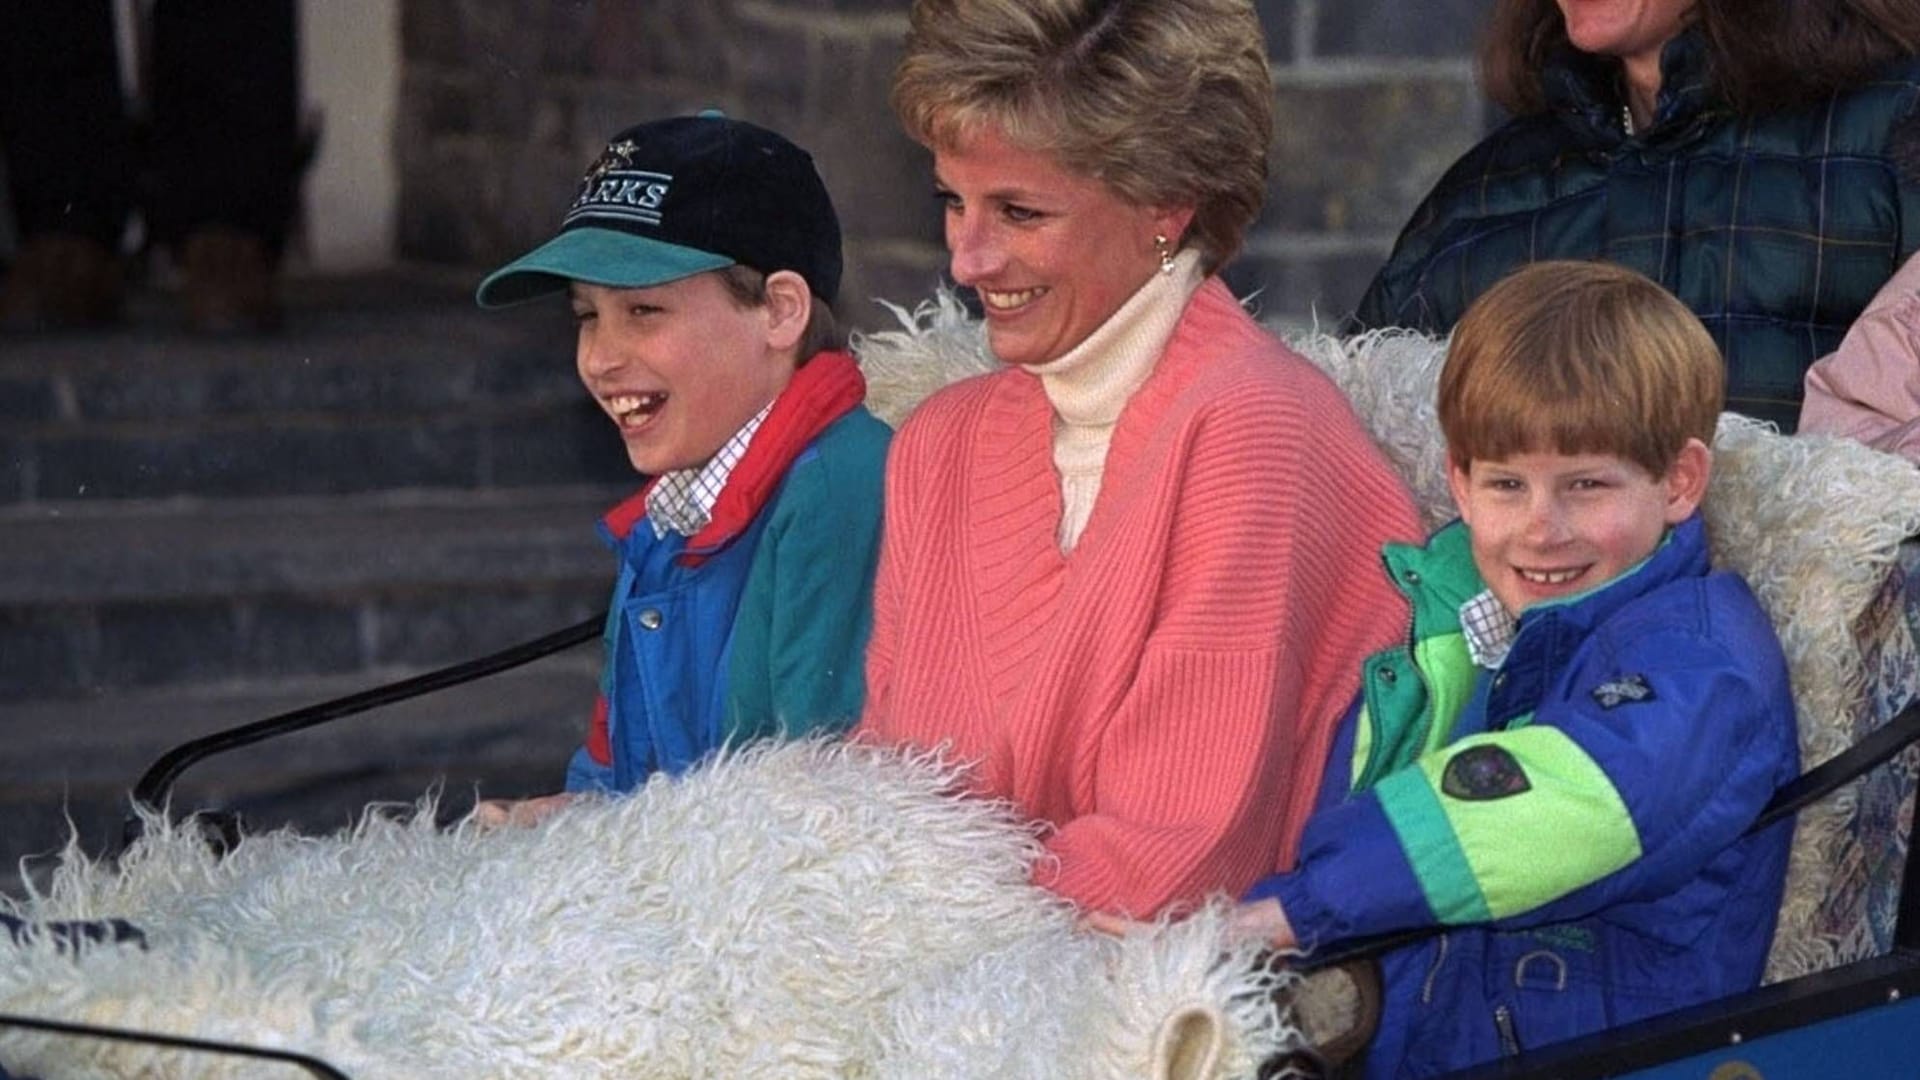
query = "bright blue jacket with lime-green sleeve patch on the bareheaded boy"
(1248, 513, 1799, 1076)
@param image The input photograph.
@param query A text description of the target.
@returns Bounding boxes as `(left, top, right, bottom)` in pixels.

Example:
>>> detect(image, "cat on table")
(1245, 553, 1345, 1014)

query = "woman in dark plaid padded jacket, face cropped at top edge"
(1356, 0, 1920, 430)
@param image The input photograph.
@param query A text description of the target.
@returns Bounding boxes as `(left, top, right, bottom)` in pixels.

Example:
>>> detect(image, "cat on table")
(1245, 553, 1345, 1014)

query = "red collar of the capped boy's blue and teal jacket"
(601, 352, 866, 567)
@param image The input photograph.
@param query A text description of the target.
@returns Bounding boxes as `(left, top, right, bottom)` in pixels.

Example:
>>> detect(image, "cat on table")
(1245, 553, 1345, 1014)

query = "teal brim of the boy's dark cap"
(474, 229, 733, 307)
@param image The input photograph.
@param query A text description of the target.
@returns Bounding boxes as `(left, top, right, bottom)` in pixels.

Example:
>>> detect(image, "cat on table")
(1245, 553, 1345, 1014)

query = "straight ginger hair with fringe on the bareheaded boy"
(1440, 261, 1726, 479)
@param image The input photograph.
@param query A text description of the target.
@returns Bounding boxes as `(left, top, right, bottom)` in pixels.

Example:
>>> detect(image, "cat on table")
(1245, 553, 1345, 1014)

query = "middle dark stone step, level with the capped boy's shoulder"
(0, 486, 624, 701)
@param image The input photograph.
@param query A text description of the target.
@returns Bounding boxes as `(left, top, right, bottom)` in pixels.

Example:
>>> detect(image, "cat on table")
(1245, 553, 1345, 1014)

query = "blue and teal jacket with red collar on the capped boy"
(566, 354, 889, 792)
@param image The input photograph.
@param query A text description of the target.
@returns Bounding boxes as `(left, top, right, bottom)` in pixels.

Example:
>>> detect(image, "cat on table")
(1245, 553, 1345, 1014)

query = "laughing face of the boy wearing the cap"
(568, 273, 793, 477)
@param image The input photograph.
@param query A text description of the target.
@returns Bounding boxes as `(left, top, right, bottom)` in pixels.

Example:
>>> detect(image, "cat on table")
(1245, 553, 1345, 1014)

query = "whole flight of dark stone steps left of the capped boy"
(0, 267, 636, 888)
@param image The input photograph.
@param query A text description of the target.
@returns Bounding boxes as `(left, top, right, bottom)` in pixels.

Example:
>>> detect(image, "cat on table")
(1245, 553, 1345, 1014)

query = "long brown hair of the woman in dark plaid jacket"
(1480, 0, 1920, 115)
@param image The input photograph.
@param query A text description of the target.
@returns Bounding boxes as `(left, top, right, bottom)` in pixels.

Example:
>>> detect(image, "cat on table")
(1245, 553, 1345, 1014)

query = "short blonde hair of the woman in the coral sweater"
(893, 0, 1273, 271)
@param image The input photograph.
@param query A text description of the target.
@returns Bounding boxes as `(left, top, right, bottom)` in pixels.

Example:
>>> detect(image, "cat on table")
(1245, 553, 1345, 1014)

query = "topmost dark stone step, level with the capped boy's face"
(0, 269, 630, 505)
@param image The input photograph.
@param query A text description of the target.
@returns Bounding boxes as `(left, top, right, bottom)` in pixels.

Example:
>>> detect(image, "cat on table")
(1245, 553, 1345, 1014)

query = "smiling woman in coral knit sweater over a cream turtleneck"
(860, 0, 1419, 917)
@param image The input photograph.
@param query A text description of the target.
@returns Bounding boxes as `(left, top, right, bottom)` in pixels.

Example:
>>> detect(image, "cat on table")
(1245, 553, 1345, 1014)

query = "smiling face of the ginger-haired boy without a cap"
(1448, 442, 1705, 615)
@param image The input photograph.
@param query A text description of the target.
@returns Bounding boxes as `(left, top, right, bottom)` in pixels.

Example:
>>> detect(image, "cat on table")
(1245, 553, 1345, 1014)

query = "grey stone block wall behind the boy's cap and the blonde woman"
(396, 0, 1488, 327)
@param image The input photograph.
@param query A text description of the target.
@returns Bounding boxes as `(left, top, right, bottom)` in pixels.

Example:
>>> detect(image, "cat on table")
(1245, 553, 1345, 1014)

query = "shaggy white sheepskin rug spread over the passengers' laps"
(0, 742, 1298, 1080)
